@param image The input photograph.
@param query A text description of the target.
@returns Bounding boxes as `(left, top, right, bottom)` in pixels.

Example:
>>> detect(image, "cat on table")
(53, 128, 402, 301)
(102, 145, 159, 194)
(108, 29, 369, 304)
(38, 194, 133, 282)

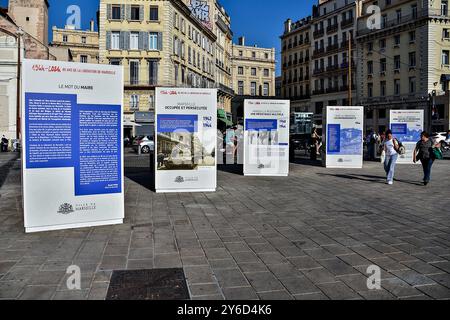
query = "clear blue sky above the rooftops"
(0, 0, 317, 74)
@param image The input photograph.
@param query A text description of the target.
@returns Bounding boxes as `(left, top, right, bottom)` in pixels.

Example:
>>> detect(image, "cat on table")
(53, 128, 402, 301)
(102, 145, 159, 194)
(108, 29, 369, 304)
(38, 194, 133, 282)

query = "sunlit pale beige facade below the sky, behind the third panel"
(232, 38, 276, 97)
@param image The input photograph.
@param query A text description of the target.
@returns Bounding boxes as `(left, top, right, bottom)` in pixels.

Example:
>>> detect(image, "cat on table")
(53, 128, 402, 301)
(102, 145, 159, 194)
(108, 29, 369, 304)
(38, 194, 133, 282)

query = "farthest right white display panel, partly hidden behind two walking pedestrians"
(389, 110, 424, 164)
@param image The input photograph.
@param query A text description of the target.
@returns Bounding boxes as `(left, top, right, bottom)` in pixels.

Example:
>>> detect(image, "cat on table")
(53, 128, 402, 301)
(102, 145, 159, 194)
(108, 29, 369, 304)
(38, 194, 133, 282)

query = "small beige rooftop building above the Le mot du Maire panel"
(50, 20, 99, 63)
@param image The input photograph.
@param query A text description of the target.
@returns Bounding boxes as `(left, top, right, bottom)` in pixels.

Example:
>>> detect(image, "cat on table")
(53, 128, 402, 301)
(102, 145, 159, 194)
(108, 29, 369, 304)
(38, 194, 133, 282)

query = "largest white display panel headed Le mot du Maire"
(22, 60, 124, 232)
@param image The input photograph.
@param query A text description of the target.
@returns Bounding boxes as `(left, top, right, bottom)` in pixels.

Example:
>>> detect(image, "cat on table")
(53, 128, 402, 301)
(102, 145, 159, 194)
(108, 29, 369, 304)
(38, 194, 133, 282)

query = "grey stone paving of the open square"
(0, 154, 450, 300)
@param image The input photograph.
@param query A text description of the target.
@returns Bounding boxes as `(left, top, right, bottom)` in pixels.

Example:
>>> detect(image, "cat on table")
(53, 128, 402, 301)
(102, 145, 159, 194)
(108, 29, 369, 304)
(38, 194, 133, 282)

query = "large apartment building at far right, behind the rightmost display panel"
(356, 0, 450, 131)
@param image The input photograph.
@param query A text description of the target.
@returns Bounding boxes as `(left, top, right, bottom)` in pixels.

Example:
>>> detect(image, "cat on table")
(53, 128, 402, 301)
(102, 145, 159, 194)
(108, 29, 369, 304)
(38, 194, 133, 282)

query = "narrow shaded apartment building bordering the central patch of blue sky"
(280, 16, 314, 112)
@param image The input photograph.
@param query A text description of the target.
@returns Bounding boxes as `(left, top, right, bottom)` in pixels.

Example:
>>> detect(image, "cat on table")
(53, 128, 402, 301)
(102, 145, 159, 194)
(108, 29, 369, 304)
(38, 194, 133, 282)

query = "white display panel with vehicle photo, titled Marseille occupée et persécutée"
(155, 88, 217, 192)
